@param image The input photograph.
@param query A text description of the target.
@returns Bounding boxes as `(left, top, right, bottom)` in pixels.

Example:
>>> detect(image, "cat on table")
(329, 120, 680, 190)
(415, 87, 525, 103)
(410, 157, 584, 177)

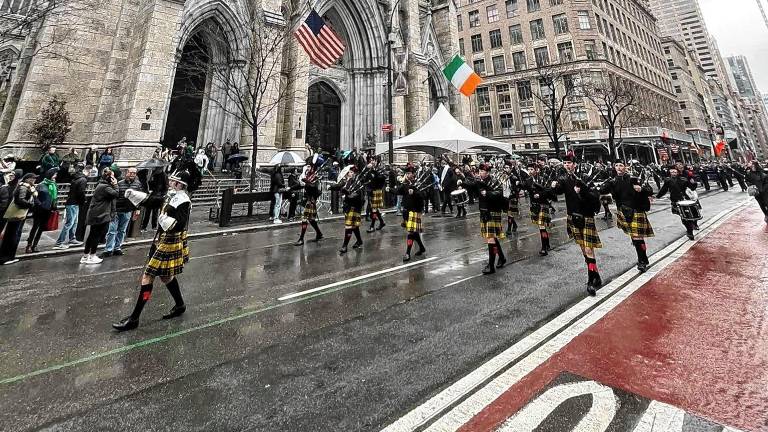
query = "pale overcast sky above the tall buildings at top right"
(699, 0, 768, 94)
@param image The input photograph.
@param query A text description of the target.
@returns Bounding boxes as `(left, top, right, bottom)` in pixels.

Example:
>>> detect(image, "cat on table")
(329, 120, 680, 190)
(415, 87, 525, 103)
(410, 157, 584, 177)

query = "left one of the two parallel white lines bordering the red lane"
(383, 203, 744, 432)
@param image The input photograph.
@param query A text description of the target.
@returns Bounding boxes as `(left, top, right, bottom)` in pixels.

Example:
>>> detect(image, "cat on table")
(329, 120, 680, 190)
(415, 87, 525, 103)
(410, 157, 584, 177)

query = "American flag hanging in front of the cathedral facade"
(294, 9, 344, 69)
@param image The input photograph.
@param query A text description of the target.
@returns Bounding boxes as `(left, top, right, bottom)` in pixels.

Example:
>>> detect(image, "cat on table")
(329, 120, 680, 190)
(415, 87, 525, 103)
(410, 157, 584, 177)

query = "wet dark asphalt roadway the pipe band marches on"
(0, 191, 745, 431)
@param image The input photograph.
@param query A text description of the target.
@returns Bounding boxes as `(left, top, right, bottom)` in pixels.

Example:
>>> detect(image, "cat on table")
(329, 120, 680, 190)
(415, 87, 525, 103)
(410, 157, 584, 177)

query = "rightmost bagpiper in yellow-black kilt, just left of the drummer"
(600, 162, 654, 272)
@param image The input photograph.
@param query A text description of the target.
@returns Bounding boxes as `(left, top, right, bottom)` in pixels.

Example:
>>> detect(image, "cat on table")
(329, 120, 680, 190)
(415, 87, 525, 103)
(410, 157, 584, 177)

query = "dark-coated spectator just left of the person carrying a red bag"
(0, 173, 37, 265)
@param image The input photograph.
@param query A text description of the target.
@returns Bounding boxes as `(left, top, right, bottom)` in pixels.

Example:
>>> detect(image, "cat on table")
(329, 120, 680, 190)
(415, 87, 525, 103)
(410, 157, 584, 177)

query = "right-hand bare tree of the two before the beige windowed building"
(580, 74, 637, 160)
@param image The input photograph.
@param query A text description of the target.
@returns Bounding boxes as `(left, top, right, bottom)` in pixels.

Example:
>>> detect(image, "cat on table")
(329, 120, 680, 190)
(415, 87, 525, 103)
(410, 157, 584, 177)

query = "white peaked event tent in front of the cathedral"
(376, 104, 512, 155)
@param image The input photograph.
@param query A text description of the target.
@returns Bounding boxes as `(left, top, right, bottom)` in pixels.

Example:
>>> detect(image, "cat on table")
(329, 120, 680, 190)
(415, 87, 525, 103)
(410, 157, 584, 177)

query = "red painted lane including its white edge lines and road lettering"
(387, 206, 768, 432)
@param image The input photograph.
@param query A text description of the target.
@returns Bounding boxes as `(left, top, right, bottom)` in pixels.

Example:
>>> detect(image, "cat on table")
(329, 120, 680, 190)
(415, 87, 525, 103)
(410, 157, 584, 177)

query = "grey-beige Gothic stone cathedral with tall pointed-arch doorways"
(0, 0, 466, 164)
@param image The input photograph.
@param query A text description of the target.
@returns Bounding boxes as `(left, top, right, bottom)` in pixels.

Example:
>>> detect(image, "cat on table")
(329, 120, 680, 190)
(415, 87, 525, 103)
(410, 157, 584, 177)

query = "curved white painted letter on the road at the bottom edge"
(497, 381, 619, 432)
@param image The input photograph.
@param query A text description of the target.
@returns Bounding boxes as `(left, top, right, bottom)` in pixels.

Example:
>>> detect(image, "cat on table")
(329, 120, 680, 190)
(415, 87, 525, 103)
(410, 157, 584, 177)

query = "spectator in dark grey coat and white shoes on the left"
(80, 168, 118, 264)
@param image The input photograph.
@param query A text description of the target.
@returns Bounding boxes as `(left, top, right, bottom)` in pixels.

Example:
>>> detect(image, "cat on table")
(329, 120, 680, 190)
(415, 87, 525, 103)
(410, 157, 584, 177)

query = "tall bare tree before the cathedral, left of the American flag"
(179, 3, 308, 189)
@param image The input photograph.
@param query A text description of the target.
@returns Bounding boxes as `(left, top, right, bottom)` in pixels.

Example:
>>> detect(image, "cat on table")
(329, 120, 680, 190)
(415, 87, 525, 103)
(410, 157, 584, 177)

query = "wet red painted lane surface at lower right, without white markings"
(460, 208, 768, 431)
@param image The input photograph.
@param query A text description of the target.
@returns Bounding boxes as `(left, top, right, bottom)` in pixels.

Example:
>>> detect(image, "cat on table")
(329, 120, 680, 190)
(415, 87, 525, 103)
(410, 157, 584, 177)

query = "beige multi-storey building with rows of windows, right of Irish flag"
(456, 0, 691, 160)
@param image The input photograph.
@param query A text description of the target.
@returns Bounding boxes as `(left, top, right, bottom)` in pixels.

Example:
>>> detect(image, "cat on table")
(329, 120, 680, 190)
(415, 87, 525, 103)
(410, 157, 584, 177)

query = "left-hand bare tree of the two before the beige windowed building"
(531, 63, 575, 156)
